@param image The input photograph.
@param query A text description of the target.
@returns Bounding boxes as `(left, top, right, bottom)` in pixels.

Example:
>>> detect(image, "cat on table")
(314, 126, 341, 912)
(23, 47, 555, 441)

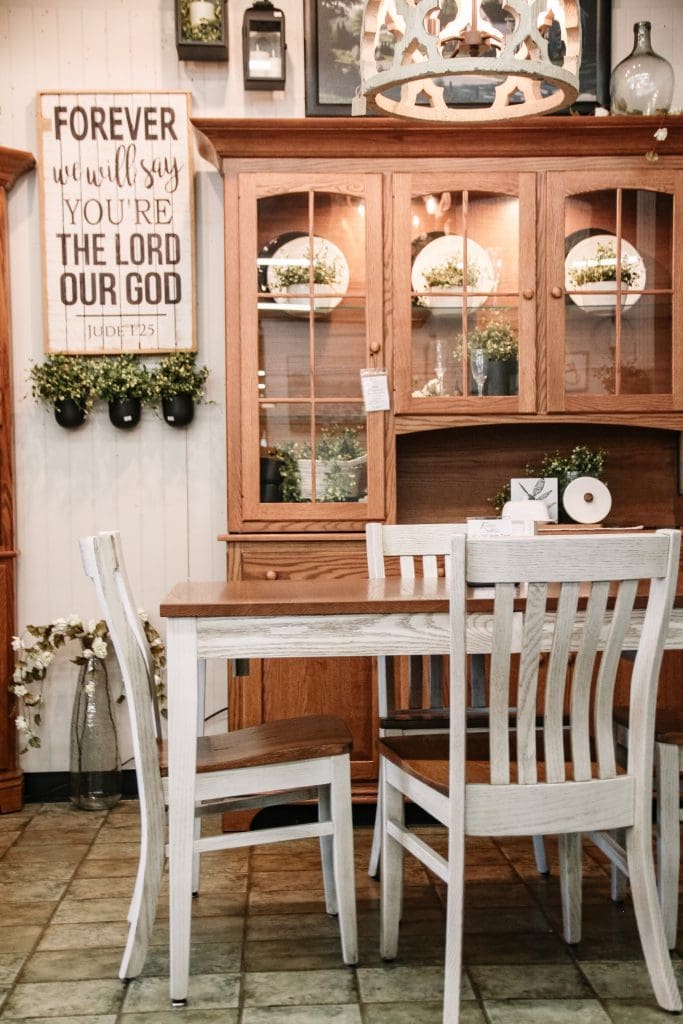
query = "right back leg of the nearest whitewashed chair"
(626, 822, 683, 1013)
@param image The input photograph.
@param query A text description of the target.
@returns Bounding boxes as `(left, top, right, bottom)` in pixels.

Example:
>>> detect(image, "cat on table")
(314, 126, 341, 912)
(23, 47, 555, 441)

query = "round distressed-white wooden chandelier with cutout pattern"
(352, 0, 581, 122)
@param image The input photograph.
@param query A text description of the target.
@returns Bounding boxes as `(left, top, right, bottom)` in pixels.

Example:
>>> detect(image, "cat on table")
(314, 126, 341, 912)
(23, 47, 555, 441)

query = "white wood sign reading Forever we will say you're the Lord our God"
(38, 92, 196, 355)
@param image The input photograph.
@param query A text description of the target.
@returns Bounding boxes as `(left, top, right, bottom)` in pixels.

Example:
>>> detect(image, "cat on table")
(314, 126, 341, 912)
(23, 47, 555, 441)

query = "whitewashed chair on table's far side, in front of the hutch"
(366, 522, 548, 878)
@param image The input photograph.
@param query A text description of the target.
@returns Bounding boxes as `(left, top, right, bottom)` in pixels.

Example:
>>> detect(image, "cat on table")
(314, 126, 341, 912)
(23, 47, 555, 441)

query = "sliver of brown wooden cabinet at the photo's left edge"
(0, 146, 36, 814)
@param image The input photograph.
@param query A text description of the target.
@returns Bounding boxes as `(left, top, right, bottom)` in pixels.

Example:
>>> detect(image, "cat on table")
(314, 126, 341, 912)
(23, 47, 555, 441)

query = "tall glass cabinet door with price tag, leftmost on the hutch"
(236, 175, 384, 528)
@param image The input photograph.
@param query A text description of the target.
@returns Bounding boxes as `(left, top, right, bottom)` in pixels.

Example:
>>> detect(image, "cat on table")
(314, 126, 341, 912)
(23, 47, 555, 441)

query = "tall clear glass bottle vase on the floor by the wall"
(71, 657, 121, 811)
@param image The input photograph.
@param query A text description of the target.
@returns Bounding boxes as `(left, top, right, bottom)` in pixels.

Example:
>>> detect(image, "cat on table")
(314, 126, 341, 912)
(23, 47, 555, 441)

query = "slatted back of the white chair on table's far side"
(366, 522, 467, 718)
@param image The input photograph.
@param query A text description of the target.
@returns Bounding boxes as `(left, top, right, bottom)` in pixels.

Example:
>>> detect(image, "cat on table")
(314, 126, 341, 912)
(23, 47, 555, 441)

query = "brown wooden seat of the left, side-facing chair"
(159, 715, 353, 776)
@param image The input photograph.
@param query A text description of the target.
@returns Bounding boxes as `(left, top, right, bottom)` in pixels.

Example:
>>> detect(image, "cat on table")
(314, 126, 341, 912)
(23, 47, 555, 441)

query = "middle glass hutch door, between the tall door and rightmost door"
(393, 172, 536, 414)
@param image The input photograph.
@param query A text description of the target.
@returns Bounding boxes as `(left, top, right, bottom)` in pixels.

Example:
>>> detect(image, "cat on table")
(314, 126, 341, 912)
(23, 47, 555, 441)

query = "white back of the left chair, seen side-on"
(80, 534, 164, 828)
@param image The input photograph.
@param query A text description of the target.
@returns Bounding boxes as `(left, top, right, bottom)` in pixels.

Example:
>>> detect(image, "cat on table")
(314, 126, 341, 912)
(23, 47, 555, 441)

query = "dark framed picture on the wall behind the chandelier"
(304, 0, 611, 117)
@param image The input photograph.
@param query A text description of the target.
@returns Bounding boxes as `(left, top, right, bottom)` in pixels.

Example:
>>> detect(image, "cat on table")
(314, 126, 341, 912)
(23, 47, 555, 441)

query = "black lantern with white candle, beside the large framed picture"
(242, 0, 287, 90)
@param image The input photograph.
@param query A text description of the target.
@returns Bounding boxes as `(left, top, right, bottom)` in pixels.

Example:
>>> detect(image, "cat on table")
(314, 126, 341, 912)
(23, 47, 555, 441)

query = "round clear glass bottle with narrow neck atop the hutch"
(609, 22, 674, 115)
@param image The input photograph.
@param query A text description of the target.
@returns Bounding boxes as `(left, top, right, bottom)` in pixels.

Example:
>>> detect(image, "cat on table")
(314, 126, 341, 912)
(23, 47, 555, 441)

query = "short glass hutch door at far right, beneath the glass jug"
(547, 169, 683, 412)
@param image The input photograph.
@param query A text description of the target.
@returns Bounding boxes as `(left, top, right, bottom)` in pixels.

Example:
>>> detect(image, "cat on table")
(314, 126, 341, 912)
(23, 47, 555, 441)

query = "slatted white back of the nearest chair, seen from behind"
(451, 530, 680, 785)
